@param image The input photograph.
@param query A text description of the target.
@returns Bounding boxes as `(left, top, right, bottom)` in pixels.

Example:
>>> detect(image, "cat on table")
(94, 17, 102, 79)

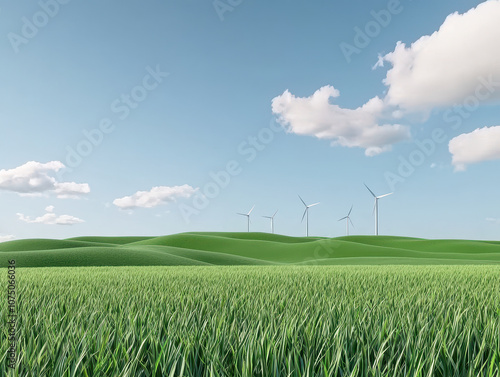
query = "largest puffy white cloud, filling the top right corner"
(377, 0, 500, 111)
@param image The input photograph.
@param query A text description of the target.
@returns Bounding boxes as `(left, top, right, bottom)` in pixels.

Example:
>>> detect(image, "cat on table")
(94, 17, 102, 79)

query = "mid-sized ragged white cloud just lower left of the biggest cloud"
(272, 86, 410, 156)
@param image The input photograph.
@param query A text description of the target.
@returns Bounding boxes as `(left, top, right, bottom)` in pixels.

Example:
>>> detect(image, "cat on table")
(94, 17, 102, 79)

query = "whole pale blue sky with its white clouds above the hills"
(0, 0, 500, 240)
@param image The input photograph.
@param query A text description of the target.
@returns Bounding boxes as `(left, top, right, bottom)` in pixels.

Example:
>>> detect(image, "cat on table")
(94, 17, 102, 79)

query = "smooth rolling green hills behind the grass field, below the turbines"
(0, 232, 500, 267)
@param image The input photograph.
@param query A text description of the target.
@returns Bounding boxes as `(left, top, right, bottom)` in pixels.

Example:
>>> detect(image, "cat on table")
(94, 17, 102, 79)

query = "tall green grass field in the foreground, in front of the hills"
(0, 266, 500, 377)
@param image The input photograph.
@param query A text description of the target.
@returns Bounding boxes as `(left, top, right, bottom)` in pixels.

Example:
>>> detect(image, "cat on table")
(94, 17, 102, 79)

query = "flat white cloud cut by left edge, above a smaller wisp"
(0, 161, 90, 198)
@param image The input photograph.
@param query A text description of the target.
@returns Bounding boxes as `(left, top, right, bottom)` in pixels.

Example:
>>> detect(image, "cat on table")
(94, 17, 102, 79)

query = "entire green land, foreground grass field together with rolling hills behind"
(0, 233, 500, 377)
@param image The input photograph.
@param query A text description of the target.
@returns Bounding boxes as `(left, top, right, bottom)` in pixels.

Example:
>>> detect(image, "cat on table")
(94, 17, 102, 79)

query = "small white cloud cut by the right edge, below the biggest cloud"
(448, 126, 500, 170)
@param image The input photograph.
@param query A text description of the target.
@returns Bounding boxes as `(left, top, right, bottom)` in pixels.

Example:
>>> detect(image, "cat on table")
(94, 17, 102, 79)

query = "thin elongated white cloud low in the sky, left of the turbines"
(113, 185, 198, 209)
